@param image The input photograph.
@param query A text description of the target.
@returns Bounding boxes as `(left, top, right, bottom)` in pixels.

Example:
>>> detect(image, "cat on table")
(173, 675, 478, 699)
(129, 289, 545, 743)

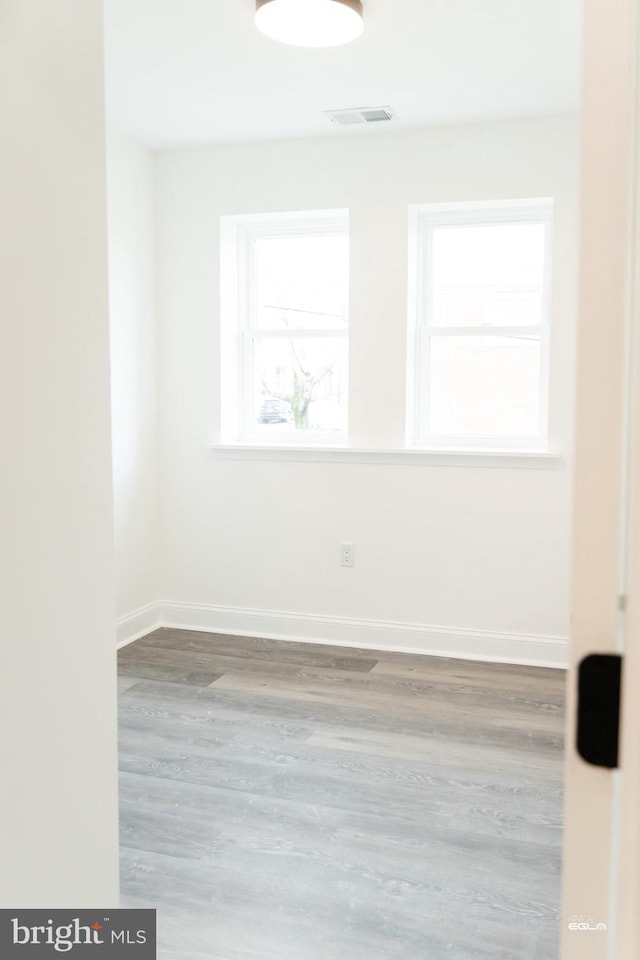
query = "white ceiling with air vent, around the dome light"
(105, 0, 580, 147)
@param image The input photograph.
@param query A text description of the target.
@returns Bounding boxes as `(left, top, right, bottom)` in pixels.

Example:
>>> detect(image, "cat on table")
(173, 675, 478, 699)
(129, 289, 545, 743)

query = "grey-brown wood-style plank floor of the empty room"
(119, 630, 565, 960)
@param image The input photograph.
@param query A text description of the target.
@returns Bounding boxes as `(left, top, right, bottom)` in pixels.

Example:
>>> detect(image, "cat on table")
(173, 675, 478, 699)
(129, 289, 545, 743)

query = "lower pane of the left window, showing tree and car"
(253, 337, 347, 436)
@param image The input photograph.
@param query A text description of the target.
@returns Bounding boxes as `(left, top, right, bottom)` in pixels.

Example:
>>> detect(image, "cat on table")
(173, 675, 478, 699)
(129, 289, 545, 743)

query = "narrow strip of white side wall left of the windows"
(108, 131, 159, 634)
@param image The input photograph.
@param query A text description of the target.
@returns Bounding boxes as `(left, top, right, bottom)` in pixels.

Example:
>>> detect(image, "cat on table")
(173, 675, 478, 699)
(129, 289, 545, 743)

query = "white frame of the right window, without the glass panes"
(407, 197, 553, 452)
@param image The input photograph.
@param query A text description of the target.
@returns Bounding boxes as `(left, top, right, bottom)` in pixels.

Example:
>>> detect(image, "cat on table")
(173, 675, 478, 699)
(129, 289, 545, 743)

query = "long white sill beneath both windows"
(209, 443, 565, 470)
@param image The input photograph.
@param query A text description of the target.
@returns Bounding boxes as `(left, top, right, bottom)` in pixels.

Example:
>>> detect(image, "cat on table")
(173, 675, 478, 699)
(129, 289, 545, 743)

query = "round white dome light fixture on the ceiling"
(256, 0, 364, 47)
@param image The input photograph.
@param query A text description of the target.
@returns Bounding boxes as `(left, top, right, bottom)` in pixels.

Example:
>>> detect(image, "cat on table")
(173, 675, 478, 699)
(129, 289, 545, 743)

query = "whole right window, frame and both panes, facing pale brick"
(409, 200, 552, 450)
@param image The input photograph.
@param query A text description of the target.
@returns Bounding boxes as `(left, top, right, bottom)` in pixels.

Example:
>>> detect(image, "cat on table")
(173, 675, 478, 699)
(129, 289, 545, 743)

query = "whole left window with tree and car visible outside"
(221, 210, 349, 444)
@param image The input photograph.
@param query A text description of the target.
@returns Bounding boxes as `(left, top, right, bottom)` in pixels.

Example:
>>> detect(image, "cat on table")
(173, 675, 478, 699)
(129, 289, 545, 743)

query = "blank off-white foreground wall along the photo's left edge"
(0, 0, 118, 907)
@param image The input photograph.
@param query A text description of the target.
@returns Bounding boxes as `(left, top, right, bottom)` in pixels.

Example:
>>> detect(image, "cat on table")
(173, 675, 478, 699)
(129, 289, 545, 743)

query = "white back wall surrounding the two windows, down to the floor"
(157, 118, 577, 662)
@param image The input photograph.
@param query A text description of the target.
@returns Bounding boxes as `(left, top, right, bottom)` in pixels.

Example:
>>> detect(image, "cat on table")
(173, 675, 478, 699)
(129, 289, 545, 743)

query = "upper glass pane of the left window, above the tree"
(254, 234, 349, 330)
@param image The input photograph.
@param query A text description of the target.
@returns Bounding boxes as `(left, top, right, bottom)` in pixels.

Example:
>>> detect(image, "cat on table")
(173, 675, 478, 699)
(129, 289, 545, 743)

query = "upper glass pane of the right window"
(431, 223, 547, 327)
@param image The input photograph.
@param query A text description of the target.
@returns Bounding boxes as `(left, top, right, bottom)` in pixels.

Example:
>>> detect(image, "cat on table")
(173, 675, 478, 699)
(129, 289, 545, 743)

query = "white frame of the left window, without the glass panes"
(220, 209, 349, 446)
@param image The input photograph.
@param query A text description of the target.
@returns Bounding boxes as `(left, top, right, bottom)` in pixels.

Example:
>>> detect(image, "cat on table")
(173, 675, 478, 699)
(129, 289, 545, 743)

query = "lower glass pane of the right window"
(429, 335, 540, 437)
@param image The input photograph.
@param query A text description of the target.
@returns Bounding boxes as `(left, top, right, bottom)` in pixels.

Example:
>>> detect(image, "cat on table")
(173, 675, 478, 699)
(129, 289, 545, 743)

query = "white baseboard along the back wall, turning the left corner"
(139, 601, 568, 668)
